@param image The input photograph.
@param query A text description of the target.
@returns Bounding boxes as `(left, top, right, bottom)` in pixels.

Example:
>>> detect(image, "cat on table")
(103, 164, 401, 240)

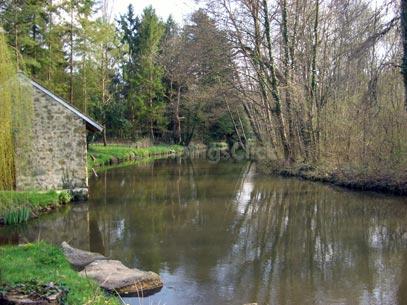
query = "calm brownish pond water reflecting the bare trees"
(0, 159, 407, 305)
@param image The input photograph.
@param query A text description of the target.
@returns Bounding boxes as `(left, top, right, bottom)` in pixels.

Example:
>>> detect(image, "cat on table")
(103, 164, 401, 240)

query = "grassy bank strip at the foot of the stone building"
(0, 191, 72, 225)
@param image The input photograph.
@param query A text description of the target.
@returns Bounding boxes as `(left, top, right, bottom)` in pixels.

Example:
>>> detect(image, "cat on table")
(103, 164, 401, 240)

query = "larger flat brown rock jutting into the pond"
(80, 260, 163, 296)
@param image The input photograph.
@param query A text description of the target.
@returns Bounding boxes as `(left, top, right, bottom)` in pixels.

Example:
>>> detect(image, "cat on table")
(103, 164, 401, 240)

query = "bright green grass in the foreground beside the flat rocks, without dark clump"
(0, 242, 119, 305)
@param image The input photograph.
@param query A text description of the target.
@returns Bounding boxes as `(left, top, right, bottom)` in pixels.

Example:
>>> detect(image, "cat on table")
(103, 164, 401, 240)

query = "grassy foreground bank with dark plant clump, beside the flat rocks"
(0, 242, 120, 305)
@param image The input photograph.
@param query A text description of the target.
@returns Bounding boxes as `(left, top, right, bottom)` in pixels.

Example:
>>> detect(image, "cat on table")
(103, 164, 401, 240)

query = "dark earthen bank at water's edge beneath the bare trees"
(257, 160, 407, 196)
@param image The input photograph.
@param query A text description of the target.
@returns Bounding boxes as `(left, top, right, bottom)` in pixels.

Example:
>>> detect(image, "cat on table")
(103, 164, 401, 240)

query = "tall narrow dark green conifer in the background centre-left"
(120, 5, 165, 139)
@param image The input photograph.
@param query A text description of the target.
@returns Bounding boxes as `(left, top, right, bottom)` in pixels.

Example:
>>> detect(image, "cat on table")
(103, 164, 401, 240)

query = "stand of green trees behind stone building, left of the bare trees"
(0, 0, 244, 145)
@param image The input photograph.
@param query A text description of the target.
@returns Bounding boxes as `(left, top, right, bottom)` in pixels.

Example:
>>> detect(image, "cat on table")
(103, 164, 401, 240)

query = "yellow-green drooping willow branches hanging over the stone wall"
(0, 28, 33, 190)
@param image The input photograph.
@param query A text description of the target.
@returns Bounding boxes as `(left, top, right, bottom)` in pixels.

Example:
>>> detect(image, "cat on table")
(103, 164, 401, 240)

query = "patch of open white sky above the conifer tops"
(113, 0, 199, 24)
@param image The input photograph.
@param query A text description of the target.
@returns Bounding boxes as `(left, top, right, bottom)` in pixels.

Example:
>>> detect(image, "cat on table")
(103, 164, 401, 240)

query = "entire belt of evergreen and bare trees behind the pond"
(0, 0, 407, 180)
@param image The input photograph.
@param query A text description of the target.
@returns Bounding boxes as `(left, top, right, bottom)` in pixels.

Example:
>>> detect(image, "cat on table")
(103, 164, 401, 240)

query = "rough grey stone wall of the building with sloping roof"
(16, 88, 88, 190)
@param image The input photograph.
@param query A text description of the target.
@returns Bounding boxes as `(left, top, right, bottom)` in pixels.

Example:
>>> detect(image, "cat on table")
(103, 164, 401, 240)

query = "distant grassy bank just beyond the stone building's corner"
(88, 144, 184, 169)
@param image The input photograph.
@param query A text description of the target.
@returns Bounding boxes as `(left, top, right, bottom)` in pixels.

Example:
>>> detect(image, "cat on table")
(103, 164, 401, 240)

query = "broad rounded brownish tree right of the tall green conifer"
(167, 10, 242, 145)
